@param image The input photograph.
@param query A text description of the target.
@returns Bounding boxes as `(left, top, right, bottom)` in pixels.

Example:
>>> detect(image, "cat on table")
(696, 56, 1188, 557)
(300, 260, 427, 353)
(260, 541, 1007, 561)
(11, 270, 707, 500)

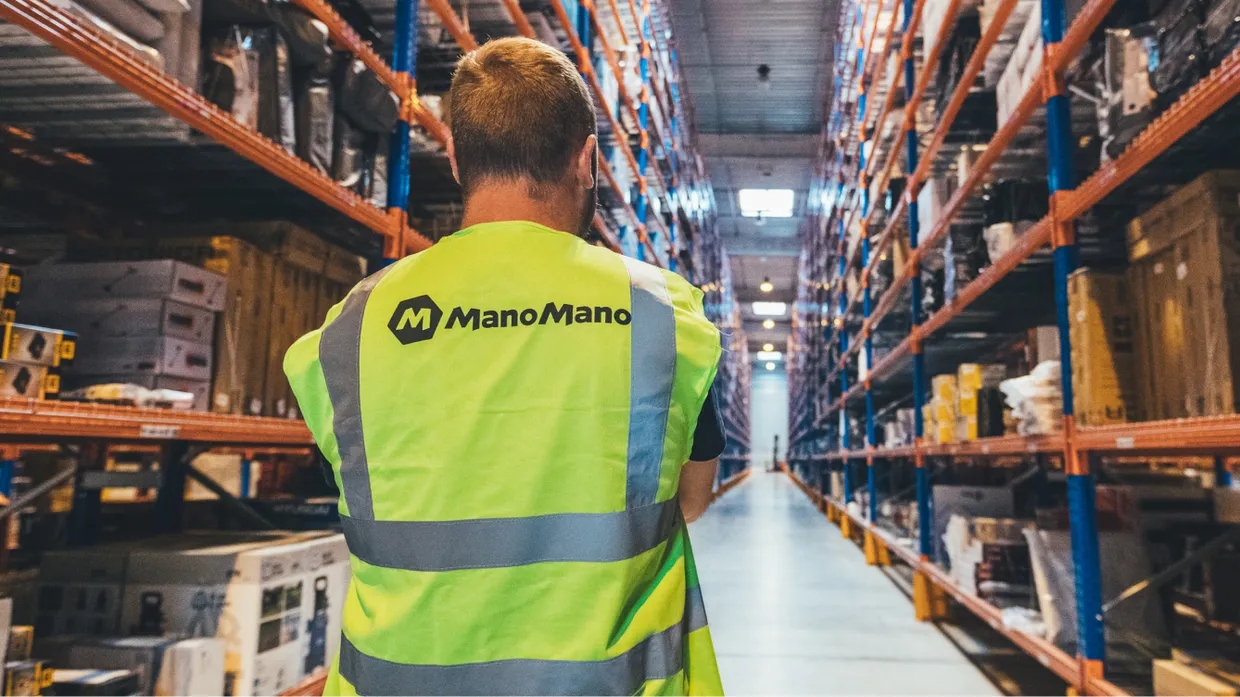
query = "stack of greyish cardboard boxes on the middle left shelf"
(22, 260, 224, 409)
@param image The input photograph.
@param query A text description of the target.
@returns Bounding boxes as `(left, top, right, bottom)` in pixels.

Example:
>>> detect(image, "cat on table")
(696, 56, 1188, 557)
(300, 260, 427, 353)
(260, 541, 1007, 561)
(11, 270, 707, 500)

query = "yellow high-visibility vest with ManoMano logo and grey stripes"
(284, 222, 723, 695)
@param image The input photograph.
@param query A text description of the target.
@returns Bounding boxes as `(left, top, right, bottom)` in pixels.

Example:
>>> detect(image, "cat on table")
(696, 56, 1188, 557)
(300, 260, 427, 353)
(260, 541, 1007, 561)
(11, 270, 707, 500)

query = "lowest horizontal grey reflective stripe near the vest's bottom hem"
(340, 610, 687, 695)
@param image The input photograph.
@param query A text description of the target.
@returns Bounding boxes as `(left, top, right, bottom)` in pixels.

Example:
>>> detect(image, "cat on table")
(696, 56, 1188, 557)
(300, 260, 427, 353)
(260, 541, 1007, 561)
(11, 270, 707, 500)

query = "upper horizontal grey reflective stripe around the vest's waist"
(340, 499, 681, 572)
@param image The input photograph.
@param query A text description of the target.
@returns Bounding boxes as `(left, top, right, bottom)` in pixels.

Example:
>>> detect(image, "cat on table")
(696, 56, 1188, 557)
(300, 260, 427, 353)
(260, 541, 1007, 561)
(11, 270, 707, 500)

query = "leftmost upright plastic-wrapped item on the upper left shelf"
(202, 26, 259, 129)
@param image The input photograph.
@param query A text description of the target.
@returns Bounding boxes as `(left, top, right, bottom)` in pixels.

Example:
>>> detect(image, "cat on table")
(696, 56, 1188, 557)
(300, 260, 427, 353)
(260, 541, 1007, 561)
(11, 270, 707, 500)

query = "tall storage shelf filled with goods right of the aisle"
(789, 0, 1240, 693)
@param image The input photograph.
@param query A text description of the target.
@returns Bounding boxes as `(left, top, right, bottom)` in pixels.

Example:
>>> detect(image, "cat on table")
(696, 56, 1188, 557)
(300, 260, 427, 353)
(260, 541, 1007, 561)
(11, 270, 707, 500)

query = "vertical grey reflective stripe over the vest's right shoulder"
(621, 257, 676, 507)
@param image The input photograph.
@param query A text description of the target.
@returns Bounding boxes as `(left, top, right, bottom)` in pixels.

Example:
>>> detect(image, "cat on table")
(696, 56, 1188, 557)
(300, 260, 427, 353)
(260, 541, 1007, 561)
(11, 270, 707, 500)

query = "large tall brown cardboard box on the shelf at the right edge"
(1128, 171, 1240, 419)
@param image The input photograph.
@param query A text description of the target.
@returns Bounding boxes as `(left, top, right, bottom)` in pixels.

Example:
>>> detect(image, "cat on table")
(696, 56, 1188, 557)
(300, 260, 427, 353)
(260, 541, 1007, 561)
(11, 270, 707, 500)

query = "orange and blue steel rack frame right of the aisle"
(789, 0, 1240, 693)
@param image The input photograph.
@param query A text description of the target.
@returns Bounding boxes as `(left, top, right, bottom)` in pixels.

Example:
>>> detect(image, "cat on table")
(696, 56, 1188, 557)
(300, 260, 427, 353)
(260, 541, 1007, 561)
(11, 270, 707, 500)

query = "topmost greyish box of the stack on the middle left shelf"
(24, 259, 224, 311)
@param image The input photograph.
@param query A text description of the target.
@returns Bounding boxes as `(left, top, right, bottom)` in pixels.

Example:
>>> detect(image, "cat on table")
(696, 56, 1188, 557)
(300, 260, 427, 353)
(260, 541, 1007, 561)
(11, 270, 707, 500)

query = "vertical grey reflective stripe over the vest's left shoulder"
(319, 265, 392, 518)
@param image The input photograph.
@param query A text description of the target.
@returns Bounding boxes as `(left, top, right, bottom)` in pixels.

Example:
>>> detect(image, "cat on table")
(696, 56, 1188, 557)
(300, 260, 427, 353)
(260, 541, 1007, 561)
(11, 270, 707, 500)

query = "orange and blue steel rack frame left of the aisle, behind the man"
(0, 0, 748, 543)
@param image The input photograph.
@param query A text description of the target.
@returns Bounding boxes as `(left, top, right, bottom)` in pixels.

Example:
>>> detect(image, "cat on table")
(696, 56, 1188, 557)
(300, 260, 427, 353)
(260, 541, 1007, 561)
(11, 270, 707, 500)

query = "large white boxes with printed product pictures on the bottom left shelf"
(36, 532, 350, 696)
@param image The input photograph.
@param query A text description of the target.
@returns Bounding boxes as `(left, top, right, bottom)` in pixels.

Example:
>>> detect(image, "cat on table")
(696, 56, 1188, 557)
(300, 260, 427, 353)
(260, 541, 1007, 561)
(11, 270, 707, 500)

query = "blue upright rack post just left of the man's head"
(383, 0, 418, 265)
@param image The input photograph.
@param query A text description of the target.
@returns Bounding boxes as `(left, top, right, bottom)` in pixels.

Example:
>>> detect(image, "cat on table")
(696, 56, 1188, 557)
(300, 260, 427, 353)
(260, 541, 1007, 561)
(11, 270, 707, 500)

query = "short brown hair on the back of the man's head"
(451, 38, 595, 196)
